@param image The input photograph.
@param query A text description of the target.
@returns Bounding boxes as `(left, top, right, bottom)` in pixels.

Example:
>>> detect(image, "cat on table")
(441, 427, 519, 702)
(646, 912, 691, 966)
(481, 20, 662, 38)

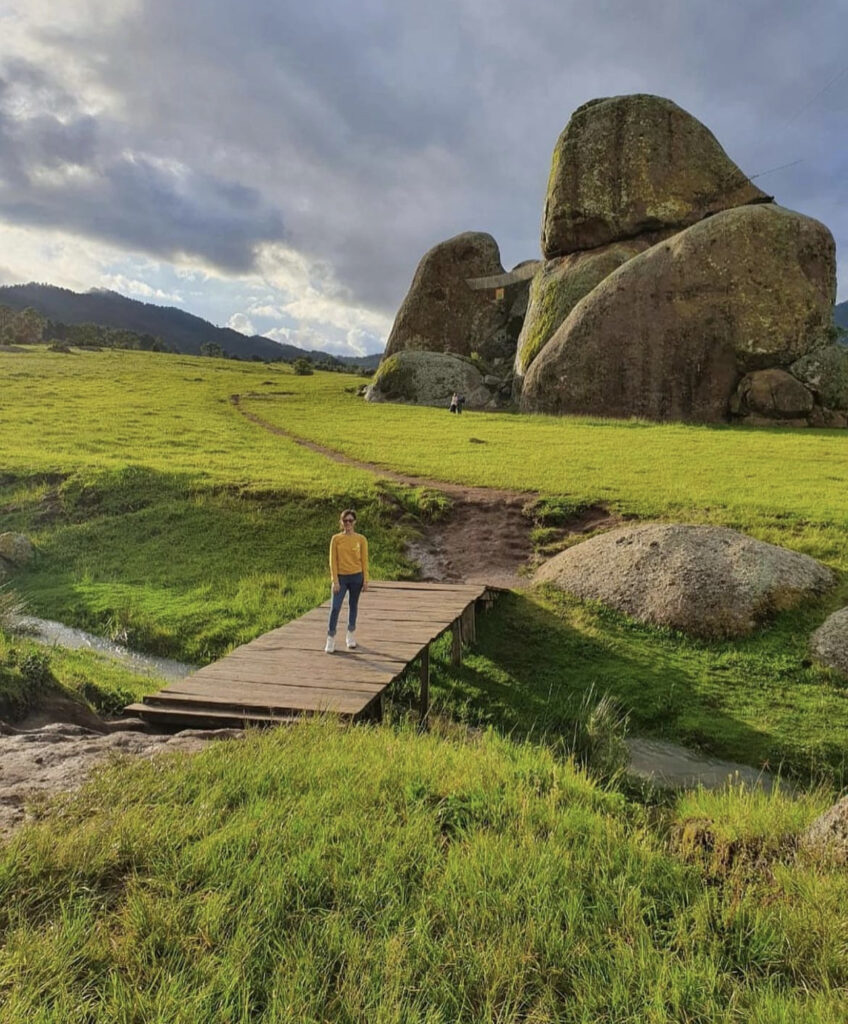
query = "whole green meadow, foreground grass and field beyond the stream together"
(0, 349, 848, 1024)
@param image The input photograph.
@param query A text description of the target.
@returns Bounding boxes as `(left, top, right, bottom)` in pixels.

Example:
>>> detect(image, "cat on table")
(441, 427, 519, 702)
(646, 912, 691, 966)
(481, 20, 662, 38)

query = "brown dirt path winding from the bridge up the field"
(229, 394, 618, 589)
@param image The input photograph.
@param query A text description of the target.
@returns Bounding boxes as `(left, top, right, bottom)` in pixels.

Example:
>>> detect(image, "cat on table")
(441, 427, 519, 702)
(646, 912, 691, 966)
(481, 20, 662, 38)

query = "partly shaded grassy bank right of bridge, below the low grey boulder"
(417, 592, 848, 780)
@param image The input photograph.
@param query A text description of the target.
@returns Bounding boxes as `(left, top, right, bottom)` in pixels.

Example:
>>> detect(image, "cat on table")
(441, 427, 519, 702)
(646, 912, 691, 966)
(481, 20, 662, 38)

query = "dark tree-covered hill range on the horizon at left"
(0, 284, 380, 369)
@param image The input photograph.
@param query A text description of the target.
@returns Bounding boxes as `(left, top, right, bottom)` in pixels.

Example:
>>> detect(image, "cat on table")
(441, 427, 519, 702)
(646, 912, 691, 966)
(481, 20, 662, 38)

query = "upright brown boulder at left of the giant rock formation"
(385, 231, 510, 358)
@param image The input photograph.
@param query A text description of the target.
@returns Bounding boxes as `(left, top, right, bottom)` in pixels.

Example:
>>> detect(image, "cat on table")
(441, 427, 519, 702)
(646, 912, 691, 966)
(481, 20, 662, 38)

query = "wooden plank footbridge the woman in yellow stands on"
(126, 582, 496, 728)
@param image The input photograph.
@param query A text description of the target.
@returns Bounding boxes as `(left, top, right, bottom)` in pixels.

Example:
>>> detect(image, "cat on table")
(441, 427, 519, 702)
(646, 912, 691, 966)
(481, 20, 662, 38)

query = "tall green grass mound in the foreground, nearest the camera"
(0, 722, 848, 1024)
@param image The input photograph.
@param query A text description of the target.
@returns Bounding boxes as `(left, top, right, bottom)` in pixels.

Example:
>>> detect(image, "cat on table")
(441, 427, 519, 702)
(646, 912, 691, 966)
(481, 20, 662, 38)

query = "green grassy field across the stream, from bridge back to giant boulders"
(0, 350, 848, 782)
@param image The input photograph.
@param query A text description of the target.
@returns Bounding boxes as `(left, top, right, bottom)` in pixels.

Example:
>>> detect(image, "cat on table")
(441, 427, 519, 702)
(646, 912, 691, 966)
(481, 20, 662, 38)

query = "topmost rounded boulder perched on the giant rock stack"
(542, 94, 769, 259)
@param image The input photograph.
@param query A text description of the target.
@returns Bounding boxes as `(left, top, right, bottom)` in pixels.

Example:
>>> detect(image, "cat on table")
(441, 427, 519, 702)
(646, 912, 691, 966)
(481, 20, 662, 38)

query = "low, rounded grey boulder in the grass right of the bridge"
(536, 523, 835, 638)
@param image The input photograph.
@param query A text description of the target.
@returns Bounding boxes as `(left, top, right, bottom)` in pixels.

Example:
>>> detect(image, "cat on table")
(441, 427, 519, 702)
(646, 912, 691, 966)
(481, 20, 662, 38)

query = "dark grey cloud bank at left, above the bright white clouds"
(0, 61, 284, 271)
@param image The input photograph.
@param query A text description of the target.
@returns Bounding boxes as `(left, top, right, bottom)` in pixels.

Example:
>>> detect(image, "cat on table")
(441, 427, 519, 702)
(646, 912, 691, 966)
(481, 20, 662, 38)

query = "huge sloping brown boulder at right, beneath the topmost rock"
(521, 204, 836, 423)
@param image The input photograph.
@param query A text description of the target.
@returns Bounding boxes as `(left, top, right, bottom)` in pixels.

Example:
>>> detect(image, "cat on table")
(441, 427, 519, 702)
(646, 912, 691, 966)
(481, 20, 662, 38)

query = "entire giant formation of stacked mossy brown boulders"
(370, 95, 848, 427)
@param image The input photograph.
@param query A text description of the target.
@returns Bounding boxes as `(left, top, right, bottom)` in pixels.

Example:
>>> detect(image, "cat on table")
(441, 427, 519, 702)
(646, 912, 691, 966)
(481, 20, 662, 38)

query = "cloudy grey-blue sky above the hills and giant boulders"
(0, 0, 848, 355)
